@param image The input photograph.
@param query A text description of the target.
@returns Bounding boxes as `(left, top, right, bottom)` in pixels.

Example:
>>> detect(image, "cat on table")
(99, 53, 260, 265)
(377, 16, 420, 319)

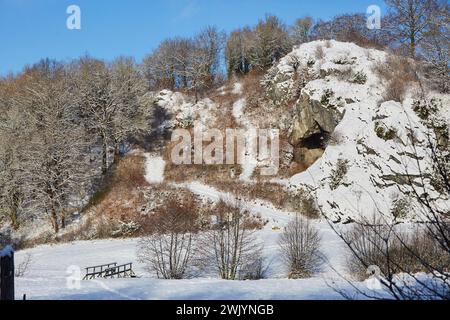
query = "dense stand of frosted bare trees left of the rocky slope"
(0, 57, 150, 233)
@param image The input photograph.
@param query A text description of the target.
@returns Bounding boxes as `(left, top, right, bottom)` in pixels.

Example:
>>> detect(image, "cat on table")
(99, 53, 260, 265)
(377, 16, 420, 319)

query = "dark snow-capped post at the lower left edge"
(0, 246, 14, 300)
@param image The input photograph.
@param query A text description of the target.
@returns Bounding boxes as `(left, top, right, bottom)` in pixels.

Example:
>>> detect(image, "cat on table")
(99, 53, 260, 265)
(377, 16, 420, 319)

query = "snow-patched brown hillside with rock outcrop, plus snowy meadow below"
(1, 40, 450, 299)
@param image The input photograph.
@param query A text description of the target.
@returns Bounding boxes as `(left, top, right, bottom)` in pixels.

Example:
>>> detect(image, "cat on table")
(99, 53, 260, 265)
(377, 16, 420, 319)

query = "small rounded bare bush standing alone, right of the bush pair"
(279, 214, 322, 278)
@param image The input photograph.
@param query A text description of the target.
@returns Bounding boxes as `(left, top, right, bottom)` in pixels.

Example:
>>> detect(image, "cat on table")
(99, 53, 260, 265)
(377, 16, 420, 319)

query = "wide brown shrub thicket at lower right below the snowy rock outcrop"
(344, 217, 450, 280)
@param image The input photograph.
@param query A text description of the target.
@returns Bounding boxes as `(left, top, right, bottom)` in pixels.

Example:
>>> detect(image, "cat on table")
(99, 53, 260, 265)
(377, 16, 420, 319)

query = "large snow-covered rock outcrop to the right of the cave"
(268, 41, 450, 221)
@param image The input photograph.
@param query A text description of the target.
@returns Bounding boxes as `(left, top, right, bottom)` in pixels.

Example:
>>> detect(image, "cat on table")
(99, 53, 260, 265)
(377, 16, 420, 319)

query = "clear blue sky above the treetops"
(0, 0, 384, 75)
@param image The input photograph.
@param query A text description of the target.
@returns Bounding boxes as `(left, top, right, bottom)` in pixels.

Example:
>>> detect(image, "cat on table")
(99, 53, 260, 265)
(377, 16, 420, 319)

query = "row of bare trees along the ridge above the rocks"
(142, 0, 450, 97)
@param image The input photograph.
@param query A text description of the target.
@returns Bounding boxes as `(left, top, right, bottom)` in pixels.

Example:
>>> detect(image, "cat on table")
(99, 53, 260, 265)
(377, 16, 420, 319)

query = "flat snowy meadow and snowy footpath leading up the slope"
(16, 174, 364, 299)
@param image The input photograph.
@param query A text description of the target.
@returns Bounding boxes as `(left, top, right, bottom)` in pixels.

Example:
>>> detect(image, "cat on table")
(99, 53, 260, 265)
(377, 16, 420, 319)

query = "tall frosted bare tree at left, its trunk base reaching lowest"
(17, 66, 88, 233)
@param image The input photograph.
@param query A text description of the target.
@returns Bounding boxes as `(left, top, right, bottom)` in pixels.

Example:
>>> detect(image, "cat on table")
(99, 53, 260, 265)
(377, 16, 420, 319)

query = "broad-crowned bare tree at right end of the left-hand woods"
(75, 57, 146, 173)
